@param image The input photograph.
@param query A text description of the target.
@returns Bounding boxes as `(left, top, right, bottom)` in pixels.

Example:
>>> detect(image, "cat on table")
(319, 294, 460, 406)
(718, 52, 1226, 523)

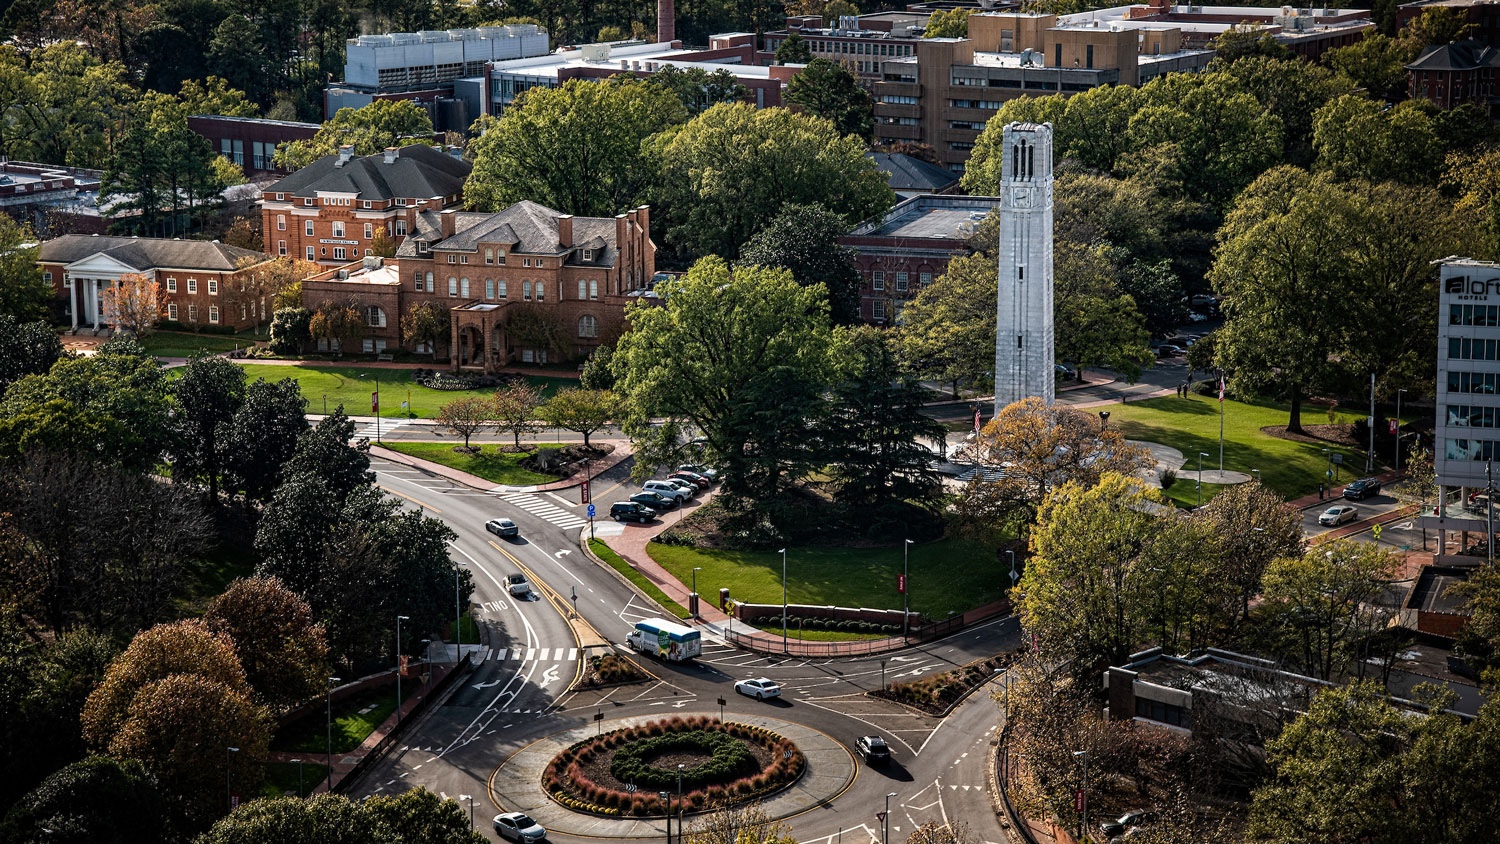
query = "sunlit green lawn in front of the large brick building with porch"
(231, 363, 578, 420)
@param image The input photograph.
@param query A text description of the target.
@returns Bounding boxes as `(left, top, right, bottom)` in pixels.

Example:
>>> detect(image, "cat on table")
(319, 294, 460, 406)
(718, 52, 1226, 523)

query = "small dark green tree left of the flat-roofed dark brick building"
(740, 204, 860, 325)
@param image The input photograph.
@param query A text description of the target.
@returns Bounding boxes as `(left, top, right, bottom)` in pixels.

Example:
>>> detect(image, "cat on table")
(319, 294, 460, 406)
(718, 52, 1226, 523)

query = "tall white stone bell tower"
(995, 123, 1056, 414)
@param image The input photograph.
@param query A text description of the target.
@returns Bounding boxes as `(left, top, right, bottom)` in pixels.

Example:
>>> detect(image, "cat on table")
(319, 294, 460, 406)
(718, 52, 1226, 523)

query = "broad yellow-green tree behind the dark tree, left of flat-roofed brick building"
(648, 103, 896, 259)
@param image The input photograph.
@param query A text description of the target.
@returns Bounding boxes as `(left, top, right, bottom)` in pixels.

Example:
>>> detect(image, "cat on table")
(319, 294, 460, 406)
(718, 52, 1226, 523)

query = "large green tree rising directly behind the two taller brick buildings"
(464, 78, 687, 217)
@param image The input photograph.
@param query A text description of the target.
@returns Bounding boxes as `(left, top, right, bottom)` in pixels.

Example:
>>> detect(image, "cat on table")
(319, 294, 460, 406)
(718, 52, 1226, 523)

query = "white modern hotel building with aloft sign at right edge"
(1422, 258, 1500, 548)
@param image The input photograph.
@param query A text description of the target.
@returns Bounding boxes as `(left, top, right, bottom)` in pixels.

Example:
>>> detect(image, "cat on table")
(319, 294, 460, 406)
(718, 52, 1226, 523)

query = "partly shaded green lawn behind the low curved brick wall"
(647, 538, 1008, 619)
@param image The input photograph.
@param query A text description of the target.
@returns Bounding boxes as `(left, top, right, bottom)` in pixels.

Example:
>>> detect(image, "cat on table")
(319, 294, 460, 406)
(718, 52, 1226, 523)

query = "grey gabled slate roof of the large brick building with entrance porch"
(396, 199, 618, 267)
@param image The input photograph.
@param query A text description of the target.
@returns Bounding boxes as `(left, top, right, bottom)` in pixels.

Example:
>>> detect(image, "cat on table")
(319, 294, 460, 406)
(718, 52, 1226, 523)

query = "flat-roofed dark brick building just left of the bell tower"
(839, 195, 1001, 325)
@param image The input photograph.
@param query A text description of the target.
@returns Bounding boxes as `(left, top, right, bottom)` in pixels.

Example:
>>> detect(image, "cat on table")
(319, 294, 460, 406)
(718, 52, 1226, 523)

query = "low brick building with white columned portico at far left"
(38, 234, 272, 333)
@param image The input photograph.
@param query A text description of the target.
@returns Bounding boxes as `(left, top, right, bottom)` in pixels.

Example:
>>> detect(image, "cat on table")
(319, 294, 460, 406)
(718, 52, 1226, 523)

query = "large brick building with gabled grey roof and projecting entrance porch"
(302, 202, 656, 372)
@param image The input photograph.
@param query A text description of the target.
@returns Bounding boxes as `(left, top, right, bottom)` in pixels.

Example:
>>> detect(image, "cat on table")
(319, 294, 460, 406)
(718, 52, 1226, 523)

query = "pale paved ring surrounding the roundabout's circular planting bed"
(489, 714, 858, 838)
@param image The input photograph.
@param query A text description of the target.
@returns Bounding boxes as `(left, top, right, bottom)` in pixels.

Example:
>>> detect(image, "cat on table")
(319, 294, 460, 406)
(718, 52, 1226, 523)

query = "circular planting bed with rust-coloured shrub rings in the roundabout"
(542, 715, 807, 817)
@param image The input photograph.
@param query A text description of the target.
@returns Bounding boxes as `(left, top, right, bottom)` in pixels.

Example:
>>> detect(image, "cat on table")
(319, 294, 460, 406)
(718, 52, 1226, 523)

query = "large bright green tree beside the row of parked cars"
(615, 258, 836, 498)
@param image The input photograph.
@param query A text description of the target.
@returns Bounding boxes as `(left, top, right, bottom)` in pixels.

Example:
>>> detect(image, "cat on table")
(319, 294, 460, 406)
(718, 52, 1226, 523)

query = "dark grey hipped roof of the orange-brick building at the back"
(267, 144, 474, 199)
